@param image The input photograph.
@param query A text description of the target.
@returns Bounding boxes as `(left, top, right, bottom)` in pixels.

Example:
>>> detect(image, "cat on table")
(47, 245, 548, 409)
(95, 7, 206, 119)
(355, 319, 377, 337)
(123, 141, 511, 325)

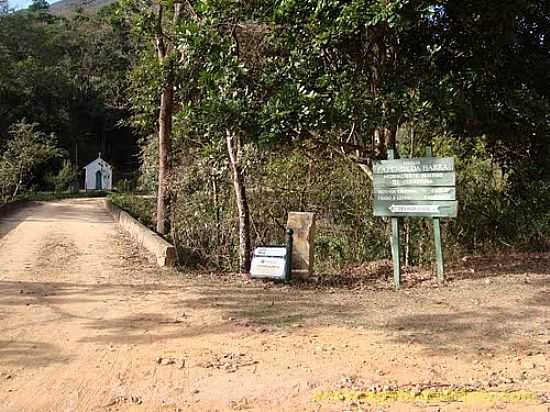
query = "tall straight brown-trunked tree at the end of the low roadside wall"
(120, 0, 190, 234)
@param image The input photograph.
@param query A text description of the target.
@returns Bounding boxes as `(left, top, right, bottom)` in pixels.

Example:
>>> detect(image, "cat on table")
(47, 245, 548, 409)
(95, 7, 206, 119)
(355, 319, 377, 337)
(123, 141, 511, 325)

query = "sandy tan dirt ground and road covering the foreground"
(0, 199, 550, 412)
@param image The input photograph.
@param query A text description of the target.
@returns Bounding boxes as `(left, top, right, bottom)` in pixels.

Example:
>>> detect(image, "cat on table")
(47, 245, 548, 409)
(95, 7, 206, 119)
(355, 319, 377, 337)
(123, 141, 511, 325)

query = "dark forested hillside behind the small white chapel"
(0, 2, 137, 199)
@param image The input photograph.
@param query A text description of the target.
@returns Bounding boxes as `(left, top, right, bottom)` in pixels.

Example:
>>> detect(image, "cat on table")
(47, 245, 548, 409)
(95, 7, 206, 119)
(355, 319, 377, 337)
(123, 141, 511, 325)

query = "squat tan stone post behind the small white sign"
(286, 212, 315, 277)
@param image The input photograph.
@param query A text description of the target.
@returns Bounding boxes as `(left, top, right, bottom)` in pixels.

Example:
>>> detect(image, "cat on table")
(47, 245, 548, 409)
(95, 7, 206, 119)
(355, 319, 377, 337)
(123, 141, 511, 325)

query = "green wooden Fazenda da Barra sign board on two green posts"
(373, 147, 458, 288)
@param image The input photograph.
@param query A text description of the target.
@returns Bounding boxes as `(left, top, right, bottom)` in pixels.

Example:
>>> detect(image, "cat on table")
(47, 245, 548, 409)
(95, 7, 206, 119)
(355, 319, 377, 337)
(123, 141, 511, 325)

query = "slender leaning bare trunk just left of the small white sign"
(225, 131, 251, 273)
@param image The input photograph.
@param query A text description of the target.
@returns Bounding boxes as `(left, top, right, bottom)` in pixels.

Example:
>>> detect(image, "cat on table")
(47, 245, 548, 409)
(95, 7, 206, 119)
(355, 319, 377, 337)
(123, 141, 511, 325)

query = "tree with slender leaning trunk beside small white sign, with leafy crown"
(170, 8, 261, 273)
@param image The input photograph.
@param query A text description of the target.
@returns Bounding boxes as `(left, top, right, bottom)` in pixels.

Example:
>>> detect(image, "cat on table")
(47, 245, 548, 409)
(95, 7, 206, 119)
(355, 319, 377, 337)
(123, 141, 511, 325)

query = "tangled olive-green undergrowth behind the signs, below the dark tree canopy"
(127, 135, 550, 273)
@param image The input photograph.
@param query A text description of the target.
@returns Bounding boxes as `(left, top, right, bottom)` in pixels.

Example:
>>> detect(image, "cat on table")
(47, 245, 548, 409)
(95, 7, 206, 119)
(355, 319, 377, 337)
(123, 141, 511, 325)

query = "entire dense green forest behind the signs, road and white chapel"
(0, 0, 550, 271)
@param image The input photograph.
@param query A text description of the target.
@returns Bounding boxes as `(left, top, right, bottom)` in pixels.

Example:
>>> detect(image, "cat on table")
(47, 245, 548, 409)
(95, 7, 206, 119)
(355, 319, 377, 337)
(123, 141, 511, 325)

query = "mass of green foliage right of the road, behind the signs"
(121, 0, 550, 270)
